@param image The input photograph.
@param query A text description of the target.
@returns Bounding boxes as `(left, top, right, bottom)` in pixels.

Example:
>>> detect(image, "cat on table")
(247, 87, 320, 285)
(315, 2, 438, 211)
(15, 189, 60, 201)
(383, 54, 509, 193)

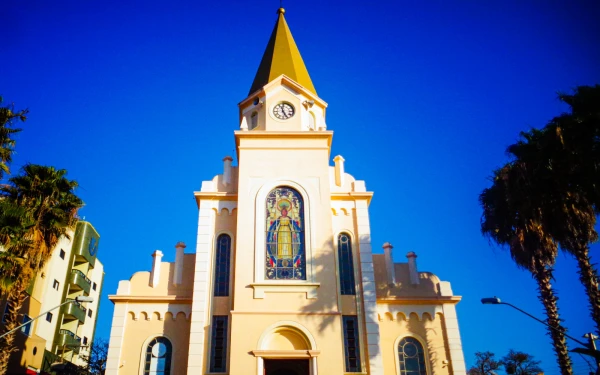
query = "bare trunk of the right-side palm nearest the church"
(533, 260, 573, 375)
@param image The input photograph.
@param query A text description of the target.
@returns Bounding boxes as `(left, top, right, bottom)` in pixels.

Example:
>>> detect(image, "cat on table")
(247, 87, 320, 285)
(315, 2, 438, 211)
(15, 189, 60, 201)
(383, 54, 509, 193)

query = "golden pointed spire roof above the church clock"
(249, 8, 317, 95)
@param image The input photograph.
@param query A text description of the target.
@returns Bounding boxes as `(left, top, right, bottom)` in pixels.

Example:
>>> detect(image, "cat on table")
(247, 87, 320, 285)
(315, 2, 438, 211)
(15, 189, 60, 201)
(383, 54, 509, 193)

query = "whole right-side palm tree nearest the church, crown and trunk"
(479, 161, 573, 375)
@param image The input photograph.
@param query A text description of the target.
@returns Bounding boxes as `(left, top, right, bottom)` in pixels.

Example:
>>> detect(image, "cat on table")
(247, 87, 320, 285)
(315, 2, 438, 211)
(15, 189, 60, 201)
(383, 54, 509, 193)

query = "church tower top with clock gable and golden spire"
(238, 8, 327, 132)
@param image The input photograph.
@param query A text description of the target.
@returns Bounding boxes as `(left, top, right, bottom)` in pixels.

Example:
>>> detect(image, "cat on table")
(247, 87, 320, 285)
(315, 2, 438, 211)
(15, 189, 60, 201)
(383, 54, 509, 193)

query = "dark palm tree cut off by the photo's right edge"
(508, 85, 600, 334)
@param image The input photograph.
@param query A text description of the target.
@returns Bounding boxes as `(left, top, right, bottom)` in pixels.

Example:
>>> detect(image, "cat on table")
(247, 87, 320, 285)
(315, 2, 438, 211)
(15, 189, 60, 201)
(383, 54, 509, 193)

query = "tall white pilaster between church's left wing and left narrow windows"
(187, 201, 215, 374)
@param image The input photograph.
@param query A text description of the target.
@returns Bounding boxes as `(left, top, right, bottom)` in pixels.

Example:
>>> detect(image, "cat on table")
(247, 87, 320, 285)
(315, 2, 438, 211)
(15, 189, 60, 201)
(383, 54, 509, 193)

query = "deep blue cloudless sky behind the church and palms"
(0, 0, 600, 374)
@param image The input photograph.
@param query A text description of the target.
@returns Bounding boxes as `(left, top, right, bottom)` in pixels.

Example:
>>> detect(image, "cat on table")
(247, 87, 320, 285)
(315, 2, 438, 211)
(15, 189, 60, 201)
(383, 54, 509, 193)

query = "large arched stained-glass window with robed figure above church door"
(265, 186, 306, 280)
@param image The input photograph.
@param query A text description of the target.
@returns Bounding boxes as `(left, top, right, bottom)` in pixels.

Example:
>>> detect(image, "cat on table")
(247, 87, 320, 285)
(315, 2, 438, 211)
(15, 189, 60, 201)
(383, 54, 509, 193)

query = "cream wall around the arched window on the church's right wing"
(379, 313, 452, 375)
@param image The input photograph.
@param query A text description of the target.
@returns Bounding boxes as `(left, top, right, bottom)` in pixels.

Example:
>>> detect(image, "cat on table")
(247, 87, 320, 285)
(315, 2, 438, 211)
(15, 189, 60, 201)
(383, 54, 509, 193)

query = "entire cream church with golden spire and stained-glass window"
(106, 8, 466, 375)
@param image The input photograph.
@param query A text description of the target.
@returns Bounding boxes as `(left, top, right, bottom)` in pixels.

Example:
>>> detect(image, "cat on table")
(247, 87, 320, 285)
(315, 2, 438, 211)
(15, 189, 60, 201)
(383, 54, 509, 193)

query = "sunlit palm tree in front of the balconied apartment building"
(0, 164, 83, 375)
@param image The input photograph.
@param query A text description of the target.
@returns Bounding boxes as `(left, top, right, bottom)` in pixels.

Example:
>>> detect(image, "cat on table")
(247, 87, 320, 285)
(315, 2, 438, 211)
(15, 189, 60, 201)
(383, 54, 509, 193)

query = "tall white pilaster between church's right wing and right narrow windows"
(356, 200, 383, 375)
